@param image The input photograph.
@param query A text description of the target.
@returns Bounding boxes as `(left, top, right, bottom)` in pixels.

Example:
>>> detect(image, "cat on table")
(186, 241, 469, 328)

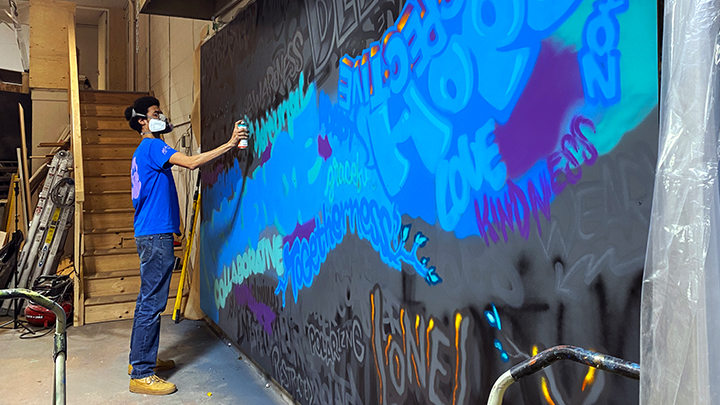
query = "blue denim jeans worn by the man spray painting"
(130, 233, 175, 378)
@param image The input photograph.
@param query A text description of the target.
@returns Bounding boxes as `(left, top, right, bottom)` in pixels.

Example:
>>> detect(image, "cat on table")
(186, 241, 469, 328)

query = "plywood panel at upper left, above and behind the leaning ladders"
(30, 0, 75, 89)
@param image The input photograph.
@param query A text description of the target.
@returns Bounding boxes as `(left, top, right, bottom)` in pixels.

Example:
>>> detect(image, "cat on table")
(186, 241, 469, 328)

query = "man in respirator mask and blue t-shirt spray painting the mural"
(125, 97, 248, 395)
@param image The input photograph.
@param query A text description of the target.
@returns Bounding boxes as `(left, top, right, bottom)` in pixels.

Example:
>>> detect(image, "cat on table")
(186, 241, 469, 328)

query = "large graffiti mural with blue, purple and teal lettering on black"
(199, 0, 657, 405)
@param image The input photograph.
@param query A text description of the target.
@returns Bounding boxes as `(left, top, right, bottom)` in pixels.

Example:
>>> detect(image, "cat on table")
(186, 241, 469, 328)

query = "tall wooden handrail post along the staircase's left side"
(67, 13, 85, 325)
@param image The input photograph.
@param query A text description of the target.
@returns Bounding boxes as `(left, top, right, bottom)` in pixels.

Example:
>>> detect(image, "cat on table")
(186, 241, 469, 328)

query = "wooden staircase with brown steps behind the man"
(75, 91, 182, 324)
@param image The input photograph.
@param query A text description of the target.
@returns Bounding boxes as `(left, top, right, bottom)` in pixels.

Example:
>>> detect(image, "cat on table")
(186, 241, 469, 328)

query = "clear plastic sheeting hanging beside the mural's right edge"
(640, 0, 720, 405)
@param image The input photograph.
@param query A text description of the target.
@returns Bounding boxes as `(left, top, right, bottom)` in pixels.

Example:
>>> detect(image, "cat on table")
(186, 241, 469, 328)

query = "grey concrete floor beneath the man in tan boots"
(0, 317, 292, 405)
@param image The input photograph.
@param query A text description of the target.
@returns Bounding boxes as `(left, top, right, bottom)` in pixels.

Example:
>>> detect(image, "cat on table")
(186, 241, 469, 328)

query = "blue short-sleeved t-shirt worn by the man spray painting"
(130, 138, 180, 237)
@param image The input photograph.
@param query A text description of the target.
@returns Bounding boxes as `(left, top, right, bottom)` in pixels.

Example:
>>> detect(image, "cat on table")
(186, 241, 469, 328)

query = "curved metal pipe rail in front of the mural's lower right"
(487, 345, 640, 405)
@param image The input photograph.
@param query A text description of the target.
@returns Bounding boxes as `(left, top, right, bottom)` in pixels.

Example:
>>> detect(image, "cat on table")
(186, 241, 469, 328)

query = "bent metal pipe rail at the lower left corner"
(0, 288, 67, 405)
